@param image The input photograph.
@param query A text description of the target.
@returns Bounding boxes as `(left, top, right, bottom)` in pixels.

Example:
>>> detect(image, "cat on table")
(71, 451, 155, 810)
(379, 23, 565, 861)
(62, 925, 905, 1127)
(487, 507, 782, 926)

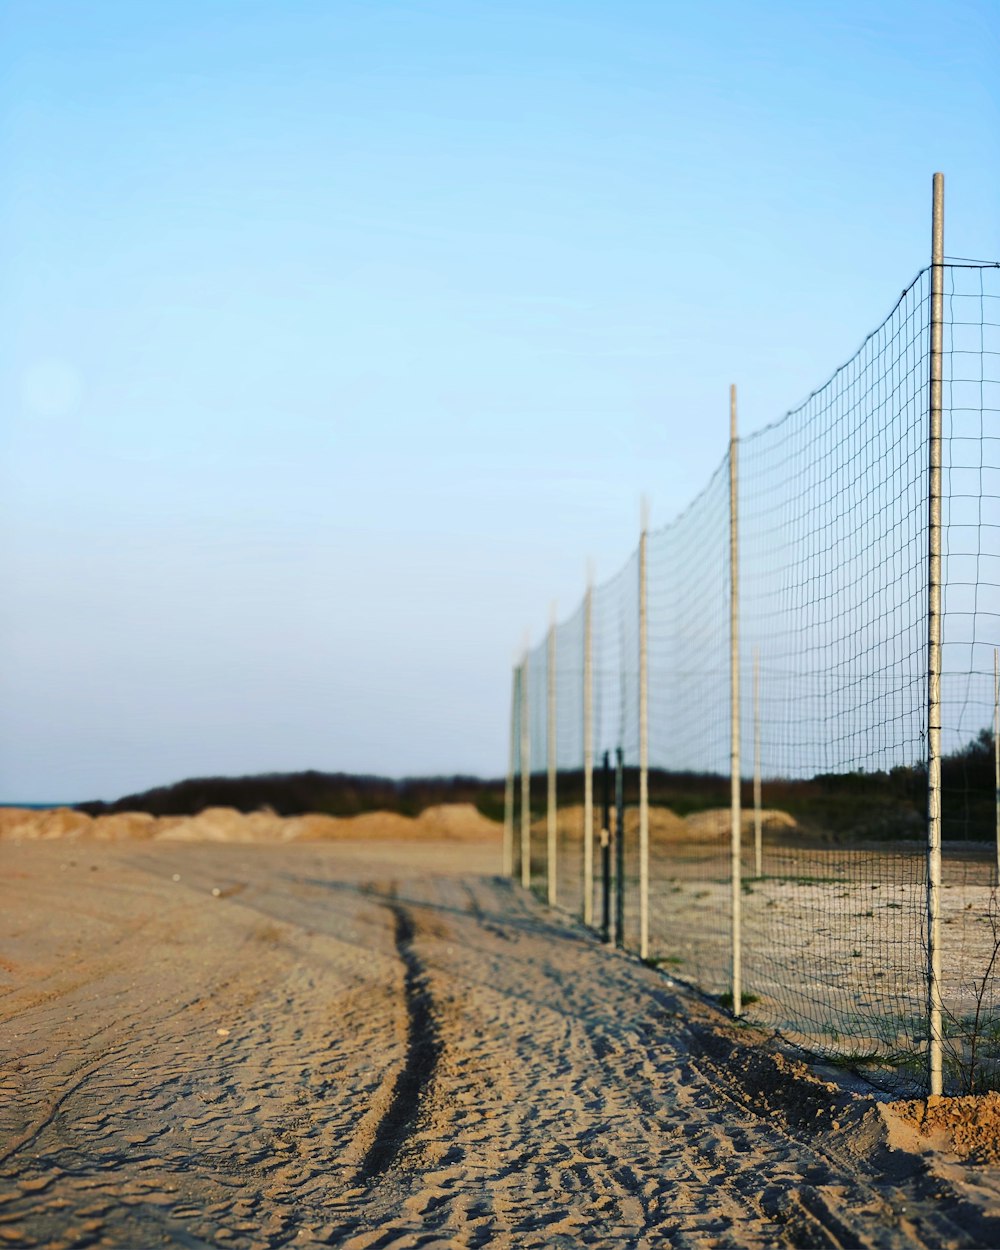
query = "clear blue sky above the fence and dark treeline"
(0, 0, 1000, 801)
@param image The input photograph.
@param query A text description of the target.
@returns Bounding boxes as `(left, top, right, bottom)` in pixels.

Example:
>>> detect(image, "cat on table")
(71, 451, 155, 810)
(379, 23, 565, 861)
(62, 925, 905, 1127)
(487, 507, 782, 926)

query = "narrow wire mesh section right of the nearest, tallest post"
(941, 265, 1000, 1091)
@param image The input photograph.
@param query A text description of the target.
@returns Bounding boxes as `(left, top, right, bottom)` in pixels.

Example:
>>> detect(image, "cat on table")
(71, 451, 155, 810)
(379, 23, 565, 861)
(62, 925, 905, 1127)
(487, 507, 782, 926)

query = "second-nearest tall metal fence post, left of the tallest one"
(729, 386, 743, 1016)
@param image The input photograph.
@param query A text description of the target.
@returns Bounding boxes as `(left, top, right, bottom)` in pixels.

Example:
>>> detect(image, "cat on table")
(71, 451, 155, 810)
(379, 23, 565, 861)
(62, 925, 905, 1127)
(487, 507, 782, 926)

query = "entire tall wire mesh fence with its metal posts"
(505, 178, 1000, 1093)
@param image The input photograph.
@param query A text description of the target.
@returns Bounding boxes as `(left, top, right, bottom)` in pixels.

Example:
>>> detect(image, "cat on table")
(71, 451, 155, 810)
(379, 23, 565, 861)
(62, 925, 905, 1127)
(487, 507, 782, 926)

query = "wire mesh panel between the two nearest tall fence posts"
(740, 273, 930, 1075)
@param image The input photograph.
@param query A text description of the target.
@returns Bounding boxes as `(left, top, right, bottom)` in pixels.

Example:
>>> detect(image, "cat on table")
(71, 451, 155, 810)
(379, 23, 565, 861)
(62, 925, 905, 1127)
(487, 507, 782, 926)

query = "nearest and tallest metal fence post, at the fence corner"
(928, 174, 945, 1098)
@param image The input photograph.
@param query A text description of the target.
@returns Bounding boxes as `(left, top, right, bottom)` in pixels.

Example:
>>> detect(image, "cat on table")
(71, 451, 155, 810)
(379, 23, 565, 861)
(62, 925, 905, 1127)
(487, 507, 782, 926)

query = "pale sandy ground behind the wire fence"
(542, 809, 1000, 1098)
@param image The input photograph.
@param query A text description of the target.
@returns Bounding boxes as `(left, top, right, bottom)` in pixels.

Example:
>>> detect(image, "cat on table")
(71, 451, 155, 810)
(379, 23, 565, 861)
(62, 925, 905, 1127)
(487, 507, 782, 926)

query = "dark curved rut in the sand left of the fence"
(359, 903, 441, 1183)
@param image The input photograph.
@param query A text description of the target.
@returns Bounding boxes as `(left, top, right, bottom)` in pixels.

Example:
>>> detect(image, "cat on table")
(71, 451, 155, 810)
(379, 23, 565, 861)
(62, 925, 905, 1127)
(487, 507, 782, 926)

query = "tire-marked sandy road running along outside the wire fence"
(0, 841, 1000, 1250)
